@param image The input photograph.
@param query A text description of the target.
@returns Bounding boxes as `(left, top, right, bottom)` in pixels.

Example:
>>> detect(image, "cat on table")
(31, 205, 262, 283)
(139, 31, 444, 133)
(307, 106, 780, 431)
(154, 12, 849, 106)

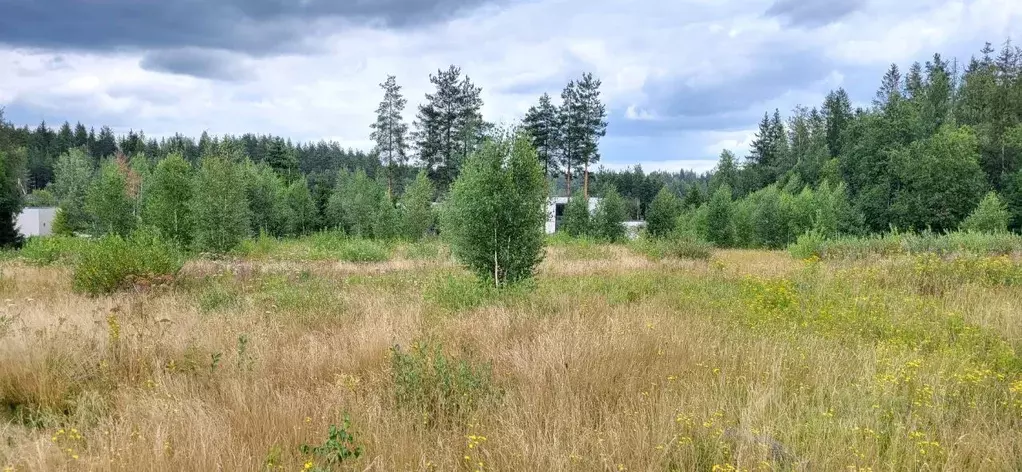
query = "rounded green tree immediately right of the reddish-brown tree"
(142, 153, 195, 247)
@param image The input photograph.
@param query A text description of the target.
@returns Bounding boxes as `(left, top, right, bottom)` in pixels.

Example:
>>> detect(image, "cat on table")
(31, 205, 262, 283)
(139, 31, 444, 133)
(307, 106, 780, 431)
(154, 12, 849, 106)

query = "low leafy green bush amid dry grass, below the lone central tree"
(390, 342, 499, 426)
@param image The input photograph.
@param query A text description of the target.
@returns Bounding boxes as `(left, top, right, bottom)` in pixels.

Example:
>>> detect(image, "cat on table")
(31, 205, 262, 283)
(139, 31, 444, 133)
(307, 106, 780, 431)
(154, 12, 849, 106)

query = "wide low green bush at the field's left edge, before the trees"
(74, 231, 184, 295)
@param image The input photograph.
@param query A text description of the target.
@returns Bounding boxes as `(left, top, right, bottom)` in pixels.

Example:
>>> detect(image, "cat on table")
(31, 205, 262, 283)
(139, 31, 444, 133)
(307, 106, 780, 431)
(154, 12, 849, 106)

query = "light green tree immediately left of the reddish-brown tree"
(85, 159, 136, 236)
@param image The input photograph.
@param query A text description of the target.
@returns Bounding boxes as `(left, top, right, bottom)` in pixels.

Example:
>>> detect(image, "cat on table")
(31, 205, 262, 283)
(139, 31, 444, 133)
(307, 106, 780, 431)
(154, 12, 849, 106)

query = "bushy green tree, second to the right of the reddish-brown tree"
(191, 147, 249, 253)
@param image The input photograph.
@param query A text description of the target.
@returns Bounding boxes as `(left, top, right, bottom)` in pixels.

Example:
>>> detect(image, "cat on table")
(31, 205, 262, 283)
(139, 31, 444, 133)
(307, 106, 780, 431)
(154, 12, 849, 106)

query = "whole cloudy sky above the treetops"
(0, 0, 1022, 172)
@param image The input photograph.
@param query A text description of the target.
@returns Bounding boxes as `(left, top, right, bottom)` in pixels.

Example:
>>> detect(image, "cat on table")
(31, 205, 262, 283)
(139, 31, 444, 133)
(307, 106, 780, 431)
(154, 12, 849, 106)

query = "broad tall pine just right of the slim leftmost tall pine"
(414, 65, 485, 191)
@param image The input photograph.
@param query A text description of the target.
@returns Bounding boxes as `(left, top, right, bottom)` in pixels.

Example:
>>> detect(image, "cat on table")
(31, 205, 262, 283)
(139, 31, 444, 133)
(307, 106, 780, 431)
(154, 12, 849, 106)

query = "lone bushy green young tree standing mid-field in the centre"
(440, 129, 547, 287)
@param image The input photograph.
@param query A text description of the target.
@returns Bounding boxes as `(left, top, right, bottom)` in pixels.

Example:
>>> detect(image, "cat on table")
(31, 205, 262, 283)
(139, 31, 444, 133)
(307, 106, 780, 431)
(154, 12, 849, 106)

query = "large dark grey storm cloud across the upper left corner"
(0, 0, 498, 54)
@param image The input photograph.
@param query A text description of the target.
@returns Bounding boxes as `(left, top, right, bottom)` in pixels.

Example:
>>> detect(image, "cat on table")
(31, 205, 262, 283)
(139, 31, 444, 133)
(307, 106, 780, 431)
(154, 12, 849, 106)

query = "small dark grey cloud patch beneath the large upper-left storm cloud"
(139, 48, 247, 81)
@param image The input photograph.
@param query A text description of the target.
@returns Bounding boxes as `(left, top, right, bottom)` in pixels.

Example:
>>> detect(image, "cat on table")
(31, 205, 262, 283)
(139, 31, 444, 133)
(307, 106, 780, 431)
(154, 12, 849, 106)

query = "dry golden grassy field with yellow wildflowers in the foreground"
(0, 241, 1022, 471)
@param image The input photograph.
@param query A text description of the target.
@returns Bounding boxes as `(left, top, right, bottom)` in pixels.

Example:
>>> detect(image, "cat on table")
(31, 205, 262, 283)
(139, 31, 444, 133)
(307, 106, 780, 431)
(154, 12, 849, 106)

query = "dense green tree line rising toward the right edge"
(633, 40, 1022, 247)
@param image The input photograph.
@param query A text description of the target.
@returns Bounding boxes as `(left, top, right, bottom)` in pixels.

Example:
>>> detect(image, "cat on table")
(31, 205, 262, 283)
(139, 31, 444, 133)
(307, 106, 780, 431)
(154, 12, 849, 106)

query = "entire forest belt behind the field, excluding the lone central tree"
(0, 40, 1022, 248)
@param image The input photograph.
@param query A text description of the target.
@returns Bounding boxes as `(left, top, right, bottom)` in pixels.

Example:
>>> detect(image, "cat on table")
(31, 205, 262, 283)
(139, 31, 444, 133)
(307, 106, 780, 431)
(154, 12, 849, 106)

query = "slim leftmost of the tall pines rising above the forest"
(369, 76, 408, 195)
